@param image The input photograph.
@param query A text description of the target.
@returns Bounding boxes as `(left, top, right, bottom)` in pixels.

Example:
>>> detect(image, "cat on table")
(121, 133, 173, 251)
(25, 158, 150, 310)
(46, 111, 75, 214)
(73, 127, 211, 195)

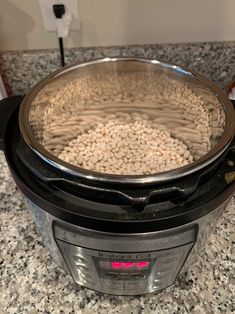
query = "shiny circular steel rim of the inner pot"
(19, 57, 235, 184)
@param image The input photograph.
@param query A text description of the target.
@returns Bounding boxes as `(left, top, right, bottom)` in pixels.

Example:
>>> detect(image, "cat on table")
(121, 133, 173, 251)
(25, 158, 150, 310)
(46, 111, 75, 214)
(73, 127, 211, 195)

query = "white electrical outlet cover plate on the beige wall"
(38, 0, 80, 32)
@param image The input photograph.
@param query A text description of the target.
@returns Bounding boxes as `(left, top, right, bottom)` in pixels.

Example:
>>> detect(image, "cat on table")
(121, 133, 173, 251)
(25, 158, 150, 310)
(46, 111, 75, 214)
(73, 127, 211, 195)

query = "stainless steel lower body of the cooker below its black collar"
(23, 190, 231, 295)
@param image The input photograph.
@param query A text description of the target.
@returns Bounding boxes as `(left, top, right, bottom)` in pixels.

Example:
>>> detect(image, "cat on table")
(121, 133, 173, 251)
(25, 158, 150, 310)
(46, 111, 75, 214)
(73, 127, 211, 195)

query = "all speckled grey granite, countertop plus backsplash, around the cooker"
(0, 43, 235, 314)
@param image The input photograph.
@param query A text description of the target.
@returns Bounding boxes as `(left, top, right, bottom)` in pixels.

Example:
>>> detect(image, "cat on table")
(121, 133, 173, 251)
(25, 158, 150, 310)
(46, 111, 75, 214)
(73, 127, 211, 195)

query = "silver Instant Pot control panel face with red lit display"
(56, 239, 194, 295)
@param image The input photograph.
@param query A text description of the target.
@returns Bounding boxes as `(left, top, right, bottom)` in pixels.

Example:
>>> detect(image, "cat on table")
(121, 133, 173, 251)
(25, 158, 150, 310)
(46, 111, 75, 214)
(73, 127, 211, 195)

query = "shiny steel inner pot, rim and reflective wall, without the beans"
(20, 58, 234, 183)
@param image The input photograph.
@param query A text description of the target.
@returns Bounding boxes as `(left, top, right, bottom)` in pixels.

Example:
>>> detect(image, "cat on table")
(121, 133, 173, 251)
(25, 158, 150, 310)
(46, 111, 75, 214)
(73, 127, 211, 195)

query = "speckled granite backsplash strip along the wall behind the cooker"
(0, 42, 235, 94)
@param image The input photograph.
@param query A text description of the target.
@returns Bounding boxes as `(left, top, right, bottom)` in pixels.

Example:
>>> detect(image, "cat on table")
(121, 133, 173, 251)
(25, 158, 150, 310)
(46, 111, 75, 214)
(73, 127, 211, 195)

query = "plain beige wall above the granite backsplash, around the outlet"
(0, 0, 235, 50)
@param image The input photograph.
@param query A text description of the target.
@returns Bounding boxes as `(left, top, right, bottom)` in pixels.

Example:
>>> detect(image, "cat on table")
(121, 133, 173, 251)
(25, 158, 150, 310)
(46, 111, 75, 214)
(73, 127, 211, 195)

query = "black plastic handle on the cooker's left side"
(0, 96, 23, 150)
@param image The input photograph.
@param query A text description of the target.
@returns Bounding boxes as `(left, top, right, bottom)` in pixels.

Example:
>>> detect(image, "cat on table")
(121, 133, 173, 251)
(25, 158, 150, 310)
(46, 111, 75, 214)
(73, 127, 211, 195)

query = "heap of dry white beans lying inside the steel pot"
(59, 119, 193, 175)
